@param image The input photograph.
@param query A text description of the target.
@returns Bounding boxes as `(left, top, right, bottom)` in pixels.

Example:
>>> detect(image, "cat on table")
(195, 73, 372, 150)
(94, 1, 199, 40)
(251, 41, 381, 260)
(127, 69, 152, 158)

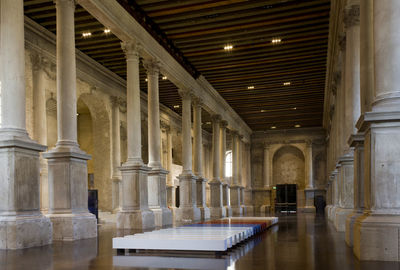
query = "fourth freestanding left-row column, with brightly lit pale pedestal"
(143, 59, 172, 226)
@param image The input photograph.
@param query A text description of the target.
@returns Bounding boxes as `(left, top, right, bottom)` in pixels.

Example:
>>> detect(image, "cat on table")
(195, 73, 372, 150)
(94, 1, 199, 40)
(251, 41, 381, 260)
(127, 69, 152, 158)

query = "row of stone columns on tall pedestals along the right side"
(327, 0, 400, 261)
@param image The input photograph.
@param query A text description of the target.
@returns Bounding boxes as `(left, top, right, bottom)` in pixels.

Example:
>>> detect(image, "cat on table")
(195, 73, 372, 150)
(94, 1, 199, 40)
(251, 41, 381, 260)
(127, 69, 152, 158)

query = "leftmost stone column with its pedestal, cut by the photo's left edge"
(0, 0, 52, 249)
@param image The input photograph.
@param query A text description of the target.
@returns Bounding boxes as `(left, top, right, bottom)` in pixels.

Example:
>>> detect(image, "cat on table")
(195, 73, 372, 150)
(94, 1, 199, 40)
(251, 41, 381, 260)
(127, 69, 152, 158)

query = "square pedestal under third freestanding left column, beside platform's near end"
(117, 162, 155, 230)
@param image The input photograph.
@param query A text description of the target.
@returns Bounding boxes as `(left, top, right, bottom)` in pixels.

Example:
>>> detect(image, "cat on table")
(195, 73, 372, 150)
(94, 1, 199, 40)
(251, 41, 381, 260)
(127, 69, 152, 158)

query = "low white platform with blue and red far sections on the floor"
(113, 217, 278, 252)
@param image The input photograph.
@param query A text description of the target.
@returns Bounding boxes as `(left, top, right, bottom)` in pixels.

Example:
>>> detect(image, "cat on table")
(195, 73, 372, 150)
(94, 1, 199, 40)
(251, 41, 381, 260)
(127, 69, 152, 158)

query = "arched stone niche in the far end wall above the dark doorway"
(272, 145, 306, 190)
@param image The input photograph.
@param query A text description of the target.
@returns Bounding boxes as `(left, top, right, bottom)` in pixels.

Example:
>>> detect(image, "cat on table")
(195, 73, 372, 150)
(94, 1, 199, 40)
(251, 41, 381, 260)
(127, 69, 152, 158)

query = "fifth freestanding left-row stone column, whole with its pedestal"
(176, 90, 201, 222)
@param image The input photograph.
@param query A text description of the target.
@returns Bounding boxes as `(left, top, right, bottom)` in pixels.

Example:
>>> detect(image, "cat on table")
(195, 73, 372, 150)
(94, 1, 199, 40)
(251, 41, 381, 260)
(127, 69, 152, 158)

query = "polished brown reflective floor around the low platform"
(0, 215, 400, 270)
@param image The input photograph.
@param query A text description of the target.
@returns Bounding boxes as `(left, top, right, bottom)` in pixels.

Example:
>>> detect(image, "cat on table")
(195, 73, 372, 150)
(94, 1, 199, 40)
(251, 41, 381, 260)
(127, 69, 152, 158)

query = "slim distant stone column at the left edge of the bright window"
(220, 120, 232, 217)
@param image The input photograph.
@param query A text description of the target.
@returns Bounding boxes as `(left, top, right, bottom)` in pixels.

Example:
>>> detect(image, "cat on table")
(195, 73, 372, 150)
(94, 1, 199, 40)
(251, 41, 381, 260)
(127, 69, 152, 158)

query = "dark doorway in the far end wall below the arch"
(275, 184, 297, 214)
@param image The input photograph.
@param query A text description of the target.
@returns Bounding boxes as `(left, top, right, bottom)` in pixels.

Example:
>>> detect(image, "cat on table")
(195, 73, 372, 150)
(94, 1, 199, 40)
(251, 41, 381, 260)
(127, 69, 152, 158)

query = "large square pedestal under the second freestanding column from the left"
(43, 150, 97, 241)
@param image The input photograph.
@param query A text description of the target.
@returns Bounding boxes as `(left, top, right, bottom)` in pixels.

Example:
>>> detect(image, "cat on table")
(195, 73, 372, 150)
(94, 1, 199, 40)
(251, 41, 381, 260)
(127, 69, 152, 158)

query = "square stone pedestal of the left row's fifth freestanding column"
(175, 173, 201, 223)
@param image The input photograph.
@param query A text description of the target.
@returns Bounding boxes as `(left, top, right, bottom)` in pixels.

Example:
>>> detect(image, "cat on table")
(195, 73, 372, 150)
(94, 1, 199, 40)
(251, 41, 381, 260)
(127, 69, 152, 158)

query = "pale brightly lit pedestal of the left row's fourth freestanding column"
(147, 168, 172, 227)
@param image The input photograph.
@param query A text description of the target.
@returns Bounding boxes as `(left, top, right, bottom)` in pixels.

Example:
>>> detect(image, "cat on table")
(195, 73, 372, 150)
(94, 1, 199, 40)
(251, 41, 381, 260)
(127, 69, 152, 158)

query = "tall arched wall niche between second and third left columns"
(77, 92, 112, 211)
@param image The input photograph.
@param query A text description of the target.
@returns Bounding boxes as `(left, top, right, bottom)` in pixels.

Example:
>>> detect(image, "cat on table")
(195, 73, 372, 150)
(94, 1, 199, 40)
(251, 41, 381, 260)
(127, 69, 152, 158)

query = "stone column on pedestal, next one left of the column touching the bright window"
(209, 115, 226, 219)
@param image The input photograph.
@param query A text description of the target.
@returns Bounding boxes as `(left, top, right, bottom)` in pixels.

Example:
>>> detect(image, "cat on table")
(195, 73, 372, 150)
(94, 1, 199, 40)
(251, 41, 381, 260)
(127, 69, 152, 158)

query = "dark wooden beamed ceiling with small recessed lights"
(24, 0, 330, 131)
